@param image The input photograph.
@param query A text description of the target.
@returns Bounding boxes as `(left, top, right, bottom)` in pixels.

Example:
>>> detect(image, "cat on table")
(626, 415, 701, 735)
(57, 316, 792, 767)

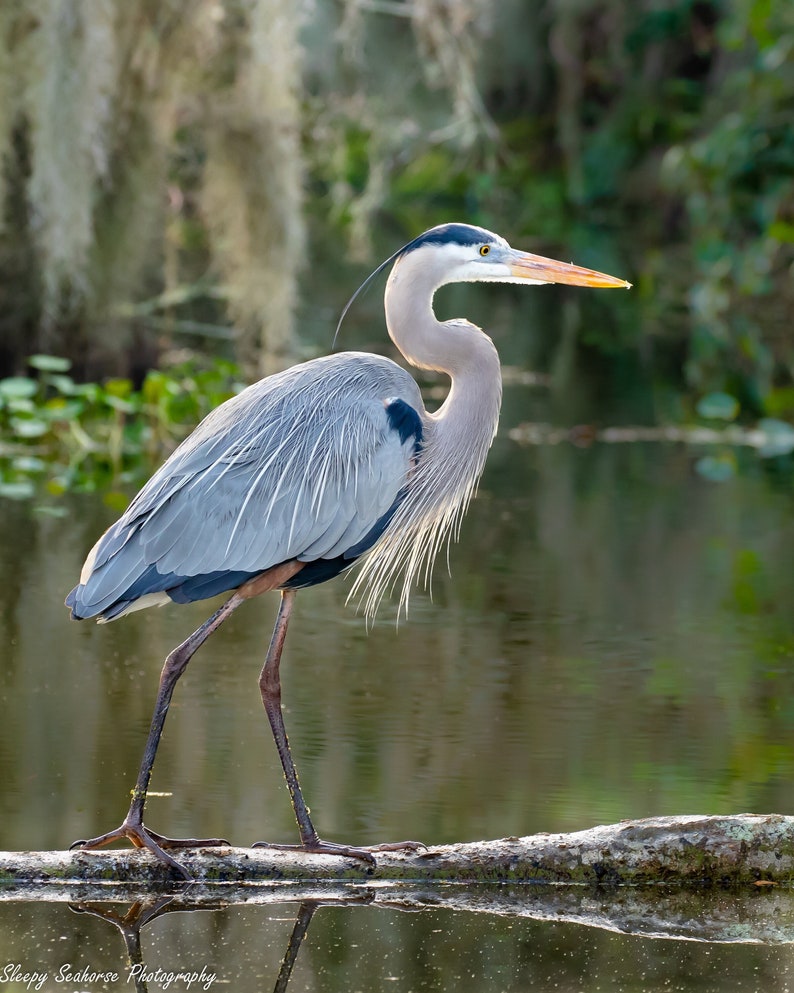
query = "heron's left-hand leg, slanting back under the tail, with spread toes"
(71, 592, 245, 879)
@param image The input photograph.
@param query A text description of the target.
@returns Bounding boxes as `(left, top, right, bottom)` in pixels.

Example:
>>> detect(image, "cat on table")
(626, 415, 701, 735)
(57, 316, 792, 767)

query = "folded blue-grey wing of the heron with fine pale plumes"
(67, 353, 422, 617)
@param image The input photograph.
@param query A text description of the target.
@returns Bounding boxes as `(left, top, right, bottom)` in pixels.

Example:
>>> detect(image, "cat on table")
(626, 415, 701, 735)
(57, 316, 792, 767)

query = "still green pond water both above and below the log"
(0, 404, 794, 993)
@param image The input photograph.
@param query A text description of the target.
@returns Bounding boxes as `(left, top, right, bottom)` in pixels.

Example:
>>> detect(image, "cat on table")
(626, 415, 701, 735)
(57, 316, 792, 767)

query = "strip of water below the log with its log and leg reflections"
(0, 887, 794, 993)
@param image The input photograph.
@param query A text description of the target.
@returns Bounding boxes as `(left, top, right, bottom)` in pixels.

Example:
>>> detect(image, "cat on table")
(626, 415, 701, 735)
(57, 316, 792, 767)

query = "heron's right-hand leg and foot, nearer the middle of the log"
(254, 590, 425, 863)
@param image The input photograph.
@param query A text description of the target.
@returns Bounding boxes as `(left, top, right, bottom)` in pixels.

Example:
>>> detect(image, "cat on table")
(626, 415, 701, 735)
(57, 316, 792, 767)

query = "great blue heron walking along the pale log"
(66, 224, 630, 878)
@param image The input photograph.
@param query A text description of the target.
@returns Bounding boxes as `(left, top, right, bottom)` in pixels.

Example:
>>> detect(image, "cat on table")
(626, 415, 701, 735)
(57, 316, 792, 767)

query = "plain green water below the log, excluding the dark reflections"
(0, 904, 794, 993)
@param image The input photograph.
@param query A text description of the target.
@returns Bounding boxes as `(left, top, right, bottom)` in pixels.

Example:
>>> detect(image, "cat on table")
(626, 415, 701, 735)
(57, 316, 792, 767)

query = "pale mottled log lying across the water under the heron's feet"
(0, 814, 794, 898)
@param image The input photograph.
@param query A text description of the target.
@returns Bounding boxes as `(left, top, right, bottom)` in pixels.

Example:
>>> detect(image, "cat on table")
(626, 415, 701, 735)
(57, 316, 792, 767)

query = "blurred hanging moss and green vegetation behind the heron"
(0, 0, 794, 484)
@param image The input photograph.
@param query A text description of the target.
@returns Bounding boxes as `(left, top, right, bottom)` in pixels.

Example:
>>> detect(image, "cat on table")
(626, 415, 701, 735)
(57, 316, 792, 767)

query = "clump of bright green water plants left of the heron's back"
(0, 355, 243, 500)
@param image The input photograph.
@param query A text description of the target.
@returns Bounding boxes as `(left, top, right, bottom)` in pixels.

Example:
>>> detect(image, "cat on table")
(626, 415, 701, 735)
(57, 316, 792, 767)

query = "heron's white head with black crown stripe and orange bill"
(390, 224, 631, 288)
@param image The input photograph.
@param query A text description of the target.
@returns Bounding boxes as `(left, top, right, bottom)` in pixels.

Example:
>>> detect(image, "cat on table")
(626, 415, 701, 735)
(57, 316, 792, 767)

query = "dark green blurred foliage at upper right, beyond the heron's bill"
(348, 0, 794, 420)
